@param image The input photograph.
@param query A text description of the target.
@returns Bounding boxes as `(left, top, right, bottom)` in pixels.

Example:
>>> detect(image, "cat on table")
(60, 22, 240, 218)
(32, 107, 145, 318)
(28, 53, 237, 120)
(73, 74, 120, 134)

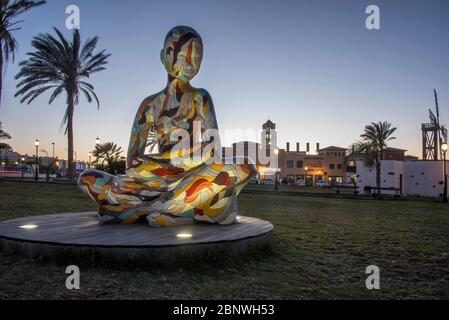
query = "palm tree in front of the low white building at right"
(351, 121, 397, 196)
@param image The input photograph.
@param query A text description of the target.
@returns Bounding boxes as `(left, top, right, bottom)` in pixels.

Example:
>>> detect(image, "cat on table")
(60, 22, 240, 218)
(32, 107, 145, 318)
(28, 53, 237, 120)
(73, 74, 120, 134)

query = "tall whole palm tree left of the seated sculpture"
(15, 28, 110, 179)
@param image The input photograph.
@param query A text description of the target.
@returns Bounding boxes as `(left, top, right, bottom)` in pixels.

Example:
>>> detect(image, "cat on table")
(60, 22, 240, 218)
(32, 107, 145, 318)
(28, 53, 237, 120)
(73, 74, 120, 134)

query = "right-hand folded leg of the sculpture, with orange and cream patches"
(146, 164, 256, 226)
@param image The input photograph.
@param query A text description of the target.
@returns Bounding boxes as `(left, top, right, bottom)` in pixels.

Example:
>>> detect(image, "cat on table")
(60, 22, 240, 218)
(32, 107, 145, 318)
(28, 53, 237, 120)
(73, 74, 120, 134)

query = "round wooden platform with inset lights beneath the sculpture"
(0, 212, 273, 263)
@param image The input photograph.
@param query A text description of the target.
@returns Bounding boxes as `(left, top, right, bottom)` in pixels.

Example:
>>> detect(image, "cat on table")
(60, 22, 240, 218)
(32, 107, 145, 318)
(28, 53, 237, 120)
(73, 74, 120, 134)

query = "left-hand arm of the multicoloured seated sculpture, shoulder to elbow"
(127, 96, 154, 168)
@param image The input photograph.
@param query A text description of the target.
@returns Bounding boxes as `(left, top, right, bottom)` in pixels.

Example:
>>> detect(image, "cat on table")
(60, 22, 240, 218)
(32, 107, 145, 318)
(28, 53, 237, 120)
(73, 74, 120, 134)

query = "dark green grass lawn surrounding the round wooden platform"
(0, 182, 449, 299)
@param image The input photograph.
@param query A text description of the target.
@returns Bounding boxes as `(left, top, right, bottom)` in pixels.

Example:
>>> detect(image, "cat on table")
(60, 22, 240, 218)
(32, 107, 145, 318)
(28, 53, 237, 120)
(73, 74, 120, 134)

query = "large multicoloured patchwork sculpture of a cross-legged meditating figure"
(78, 26, 256, 226)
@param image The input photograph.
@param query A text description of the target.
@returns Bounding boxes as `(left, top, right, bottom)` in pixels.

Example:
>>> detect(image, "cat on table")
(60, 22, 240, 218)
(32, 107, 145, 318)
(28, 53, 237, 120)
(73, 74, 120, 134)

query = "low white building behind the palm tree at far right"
(356, 160, 449, 197)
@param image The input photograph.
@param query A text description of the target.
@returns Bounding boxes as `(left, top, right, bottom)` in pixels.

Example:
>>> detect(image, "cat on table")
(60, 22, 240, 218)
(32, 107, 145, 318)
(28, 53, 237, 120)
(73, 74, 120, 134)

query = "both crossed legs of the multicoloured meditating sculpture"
(78, 164, 256, 226)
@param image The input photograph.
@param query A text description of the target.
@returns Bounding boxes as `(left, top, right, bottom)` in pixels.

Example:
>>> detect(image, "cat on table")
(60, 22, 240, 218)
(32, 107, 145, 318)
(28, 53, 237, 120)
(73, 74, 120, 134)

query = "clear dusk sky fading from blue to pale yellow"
(0, 0, 449, 160)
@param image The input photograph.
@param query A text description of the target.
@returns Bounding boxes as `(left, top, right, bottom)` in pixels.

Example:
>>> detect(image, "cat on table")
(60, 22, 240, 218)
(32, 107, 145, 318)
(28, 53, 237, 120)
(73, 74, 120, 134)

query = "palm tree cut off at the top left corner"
(0, 0, 45, 106)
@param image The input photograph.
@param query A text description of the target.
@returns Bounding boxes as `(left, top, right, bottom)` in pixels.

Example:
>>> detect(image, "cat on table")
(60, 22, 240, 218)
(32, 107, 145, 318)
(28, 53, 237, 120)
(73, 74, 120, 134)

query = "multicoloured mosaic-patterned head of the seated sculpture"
(161, 26, 203, 81)
